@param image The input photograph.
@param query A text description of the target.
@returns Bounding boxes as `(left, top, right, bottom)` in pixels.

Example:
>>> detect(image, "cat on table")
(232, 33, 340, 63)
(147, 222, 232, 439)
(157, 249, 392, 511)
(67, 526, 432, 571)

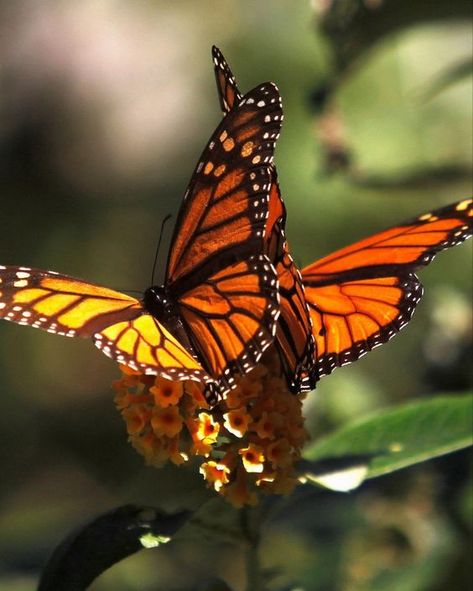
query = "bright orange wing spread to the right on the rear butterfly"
(302, 199, 473, 377)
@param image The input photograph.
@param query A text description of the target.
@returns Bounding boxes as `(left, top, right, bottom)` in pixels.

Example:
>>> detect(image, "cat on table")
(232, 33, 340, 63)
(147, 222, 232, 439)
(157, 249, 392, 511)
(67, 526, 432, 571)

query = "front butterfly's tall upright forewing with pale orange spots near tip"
(166, 82, 282, 286)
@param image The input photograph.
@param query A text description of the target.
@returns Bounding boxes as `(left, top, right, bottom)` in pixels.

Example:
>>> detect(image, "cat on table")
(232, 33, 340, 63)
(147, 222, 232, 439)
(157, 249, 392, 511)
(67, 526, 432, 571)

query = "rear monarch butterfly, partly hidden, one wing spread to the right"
(212, 47, 473, 392)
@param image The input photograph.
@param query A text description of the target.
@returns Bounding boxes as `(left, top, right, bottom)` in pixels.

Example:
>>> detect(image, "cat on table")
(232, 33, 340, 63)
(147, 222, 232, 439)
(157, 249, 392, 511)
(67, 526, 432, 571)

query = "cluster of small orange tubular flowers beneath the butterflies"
(114, 353, 308, 507)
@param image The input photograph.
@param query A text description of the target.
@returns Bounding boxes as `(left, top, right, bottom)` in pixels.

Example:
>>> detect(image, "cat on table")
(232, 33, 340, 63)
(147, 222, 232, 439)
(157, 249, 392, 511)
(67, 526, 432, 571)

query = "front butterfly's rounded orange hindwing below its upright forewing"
(180, 255, 279, 390)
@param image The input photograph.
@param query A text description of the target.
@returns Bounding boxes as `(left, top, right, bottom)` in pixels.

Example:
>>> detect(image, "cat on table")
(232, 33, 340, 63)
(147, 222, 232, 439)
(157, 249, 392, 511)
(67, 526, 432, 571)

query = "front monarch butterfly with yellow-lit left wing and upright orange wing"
(0, 51, 282, 394)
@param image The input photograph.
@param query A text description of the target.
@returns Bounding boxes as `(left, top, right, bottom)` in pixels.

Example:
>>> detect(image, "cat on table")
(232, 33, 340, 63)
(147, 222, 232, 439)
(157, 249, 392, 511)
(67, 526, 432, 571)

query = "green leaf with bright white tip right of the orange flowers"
(301, 395, 473, 491)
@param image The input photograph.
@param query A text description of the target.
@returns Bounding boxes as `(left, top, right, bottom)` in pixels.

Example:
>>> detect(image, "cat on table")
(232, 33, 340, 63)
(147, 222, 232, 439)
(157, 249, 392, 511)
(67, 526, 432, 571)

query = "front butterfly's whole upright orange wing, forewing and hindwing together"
(162, 63, 283, 392)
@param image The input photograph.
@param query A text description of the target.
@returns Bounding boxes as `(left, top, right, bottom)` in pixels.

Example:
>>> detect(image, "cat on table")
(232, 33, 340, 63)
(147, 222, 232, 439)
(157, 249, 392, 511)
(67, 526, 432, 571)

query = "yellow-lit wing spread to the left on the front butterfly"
(0, 266, 211, 381)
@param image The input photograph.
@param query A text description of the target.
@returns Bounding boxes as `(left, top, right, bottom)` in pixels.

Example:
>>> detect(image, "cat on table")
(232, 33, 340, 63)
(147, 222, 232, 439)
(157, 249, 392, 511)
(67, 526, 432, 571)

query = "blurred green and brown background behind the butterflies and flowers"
(0, 0, 473, 591)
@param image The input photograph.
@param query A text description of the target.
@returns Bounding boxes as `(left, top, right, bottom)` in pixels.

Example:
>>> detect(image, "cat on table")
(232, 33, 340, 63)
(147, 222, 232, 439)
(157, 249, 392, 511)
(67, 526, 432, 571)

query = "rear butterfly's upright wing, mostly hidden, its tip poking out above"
(212, 46, 316, 392)
